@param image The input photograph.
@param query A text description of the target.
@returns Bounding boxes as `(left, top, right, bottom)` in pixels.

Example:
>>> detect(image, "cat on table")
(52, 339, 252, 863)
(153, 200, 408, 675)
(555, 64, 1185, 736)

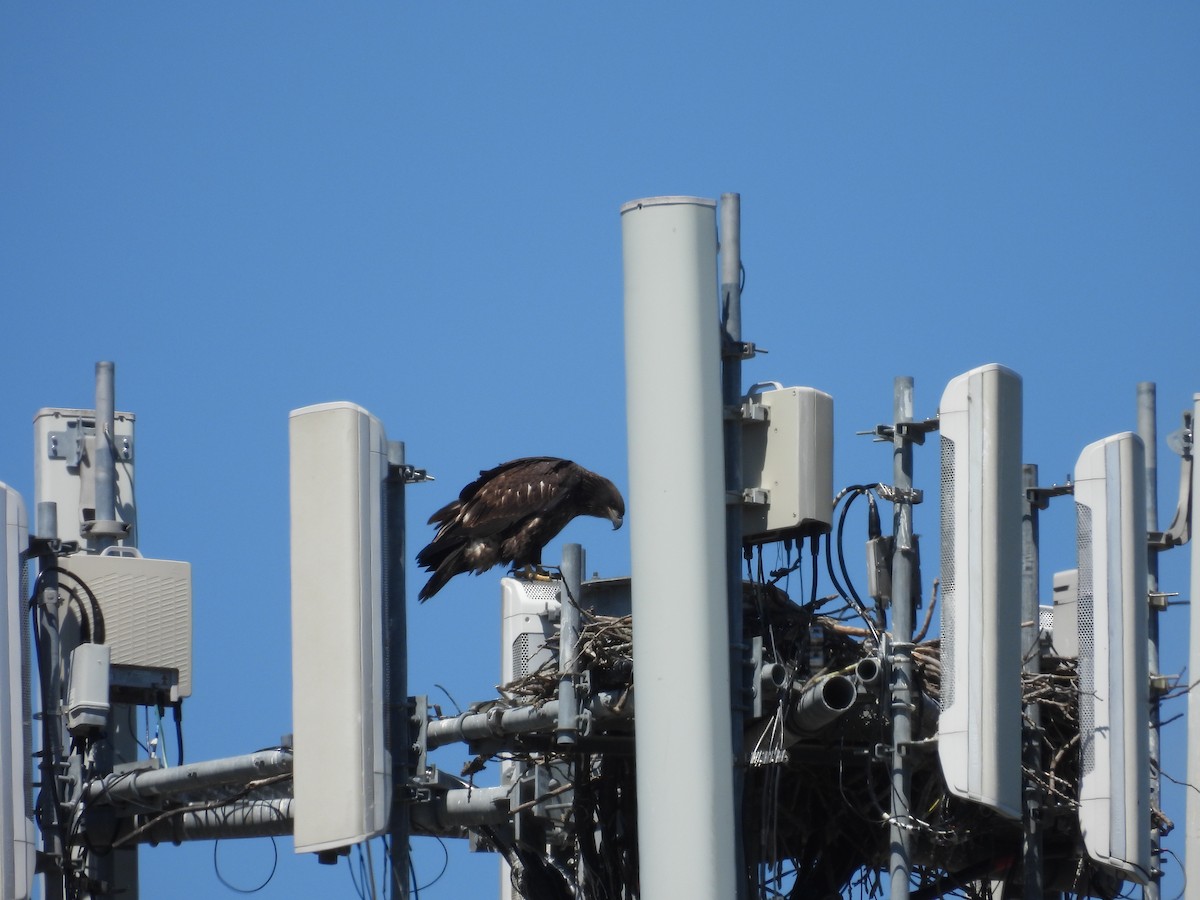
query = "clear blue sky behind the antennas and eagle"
(0, 7, 1200, 900)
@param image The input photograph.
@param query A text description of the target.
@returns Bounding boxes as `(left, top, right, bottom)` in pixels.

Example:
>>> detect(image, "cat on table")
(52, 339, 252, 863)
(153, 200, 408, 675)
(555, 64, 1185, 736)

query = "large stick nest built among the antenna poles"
(487, 584, 1118, 898)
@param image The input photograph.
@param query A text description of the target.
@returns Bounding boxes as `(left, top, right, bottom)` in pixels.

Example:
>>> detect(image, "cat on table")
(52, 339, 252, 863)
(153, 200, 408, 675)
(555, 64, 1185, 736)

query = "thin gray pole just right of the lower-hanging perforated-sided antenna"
(1138, 382, 1163, 900)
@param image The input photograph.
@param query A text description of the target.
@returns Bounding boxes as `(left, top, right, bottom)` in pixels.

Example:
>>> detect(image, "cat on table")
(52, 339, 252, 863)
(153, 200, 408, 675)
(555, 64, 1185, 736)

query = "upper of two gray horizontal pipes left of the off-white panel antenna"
(83, 749, 292, 805)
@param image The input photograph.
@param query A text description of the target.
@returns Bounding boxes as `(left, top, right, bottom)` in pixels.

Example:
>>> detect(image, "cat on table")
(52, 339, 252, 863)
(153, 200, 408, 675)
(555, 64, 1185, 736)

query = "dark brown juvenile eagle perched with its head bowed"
(416, 456, 625, 601)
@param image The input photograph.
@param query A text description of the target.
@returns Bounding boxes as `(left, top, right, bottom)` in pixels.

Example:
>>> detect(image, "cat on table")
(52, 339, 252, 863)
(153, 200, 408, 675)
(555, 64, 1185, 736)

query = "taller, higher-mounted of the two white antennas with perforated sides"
(937, 365, 1022, 818)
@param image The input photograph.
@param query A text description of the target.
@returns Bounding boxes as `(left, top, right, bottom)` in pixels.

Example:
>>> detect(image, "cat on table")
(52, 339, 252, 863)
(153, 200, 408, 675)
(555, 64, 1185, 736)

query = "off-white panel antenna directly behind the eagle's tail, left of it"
(289, 403, 391, 853)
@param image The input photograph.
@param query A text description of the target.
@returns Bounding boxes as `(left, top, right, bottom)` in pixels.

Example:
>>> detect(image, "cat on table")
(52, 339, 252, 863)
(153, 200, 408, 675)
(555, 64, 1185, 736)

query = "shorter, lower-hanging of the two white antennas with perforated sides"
(1075, 432, 1151, 884)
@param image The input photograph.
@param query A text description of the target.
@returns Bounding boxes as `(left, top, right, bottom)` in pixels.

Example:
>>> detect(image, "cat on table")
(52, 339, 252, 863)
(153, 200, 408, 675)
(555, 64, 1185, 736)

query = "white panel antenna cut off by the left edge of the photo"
(0, 484, 36, 900)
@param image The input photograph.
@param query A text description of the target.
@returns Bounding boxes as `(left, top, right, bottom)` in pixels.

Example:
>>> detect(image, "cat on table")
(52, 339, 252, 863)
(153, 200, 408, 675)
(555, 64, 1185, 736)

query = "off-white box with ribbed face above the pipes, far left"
(59, 553, 192, 702)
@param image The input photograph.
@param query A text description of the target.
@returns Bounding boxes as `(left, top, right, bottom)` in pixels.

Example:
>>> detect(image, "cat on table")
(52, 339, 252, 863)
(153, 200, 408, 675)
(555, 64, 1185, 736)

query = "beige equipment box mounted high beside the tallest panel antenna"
(742, 388, 833, 544)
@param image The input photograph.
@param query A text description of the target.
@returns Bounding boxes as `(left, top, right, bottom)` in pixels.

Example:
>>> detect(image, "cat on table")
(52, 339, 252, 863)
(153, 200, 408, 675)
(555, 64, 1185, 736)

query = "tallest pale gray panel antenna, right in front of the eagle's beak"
(622, 197, 737, 900)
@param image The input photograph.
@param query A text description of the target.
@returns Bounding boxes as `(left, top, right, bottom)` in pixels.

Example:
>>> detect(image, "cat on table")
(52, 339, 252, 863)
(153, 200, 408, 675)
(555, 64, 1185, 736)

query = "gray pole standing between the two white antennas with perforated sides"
(1021, 466, 1043, 900)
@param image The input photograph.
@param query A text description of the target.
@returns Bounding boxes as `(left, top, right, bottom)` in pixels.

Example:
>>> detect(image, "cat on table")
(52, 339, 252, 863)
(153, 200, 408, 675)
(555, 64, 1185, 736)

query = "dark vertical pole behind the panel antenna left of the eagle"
(383, 440, 412, 900)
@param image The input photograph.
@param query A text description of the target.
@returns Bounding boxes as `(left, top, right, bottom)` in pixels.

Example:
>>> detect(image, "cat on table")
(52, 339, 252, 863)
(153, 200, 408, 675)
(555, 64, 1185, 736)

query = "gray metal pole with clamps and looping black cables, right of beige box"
(888, 376, 916, 900)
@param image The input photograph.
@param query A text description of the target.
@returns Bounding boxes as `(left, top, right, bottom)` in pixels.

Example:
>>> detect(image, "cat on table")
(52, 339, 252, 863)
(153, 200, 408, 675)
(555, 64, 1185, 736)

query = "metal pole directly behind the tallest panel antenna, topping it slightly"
(718, 193, 750, 898)
